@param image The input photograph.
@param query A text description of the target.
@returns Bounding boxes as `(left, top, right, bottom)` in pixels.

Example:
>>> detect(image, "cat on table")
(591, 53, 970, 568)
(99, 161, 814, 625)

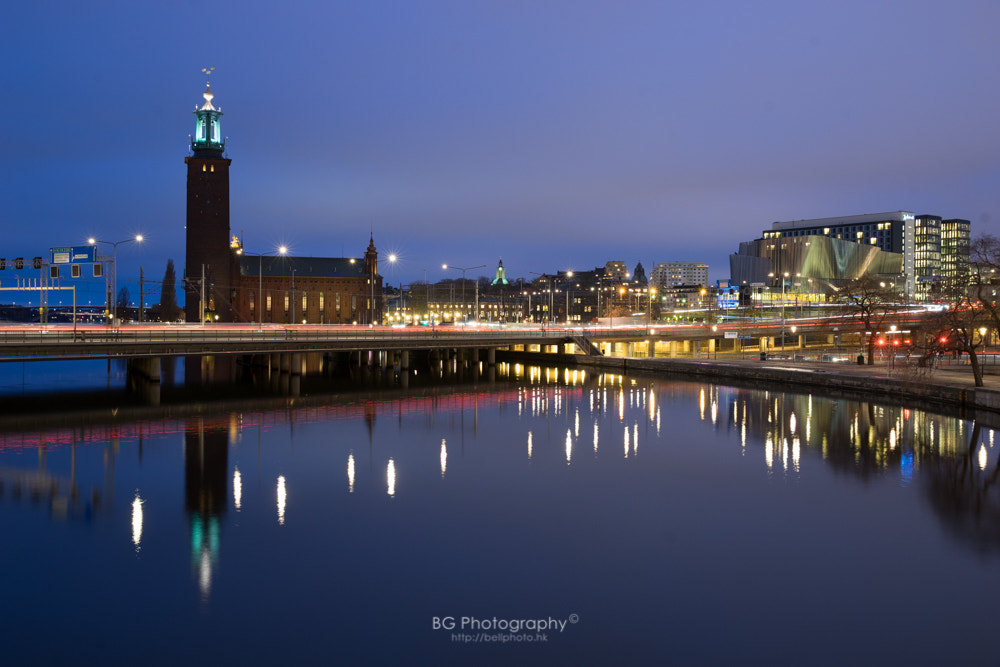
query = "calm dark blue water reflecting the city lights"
(0, 358, 1000, 665)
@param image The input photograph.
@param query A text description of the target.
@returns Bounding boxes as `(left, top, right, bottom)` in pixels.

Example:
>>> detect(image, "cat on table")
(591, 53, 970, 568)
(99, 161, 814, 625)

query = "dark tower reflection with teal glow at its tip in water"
(184, 419, 228, 599)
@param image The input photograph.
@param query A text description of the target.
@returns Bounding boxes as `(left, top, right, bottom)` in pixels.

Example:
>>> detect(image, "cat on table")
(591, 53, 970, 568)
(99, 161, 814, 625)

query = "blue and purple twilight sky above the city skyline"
(0, 0, 1000, 302)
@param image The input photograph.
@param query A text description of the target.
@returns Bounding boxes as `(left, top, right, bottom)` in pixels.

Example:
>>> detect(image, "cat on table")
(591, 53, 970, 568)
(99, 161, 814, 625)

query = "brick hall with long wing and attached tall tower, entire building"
(184, 78, 382, 323)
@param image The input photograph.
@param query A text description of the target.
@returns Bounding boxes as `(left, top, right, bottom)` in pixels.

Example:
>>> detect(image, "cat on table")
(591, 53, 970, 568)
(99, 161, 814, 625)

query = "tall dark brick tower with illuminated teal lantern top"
(184, 72, 232, 322)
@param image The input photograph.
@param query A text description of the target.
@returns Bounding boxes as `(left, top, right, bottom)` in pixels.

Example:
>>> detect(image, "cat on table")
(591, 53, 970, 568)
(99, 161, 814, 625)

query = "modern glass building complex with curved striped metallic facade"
(729, 211, 969, 297)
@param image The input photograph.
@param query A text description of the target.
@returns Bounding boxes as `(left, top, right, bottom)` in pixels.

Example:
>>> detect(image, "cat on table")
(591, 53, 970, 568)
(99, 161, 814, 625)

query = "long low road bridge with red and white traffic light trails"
(0, 318, 880, 362)
